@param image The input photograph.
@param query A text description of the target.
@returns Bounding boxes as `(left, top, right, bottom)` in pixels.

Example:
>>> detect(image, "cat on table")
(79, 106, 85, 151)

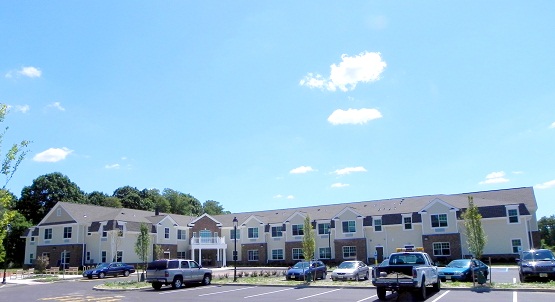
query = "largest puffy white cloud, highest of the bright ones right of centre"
(299, 51, 387, 91)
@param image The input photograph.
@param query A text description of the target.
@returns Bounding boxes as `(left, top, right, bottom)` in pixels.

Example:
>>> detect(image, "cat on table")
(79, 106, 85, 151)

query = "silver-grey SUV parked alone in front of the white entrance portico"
(145, 259, 212, 290)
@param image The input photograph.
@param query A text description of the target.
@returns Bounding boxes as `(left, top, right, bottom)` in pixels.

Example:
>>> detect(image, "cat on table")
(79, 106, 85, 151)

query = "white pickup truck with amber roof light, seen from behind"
(372, 248, 441, 300)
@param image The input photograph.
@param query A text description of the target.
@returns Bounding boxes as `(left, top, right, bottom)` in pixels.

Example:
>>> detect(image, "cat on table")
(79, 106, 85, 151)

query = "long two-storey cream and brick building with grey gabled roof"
(24, 187, 540, 266)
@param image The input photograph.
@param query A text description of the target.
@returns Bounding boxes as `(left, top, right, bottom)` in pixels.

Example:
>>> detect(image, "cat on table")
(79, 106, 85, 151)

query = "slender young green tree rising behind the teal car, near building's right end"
(462, 196, 487, 259)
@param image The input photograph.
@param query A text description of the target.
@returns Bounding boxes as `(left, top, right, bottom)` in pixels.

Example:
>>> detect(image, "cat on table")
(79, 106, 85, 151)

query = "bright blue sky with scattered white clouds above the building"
(0, 1, 555, 218)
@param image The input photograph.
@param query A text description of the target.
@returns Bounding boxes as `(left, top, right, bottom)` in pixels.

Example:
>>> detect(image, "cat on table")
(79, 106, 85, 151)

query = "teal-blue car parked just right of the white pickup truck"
(439, 259, 489, 282)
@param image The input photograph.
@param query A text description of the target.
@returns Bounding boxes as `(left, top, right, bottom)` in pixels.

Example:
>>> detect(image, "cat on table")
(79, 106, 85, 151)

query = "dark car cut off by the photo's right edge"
(517, 249, 555, 282)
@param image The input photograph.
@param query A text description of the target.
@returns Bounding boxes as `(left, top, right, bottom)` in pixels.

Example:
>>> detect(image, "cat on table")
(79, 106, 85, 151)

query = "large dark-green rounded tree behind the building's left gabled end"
(16, 172, 86, 224)
